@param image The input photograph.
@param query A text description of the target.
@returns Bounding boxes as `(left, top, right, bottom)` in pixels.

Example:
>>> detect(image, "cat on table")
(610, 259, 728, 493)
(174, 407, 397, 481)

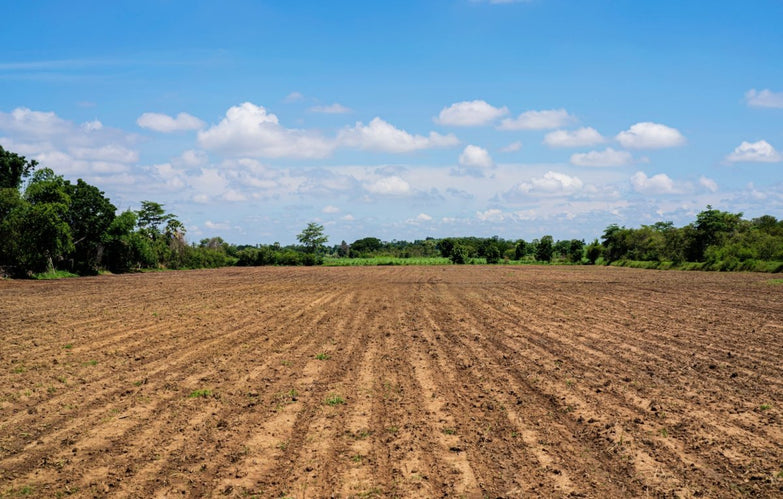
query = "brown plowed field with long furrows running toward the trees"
(0, 266, 783, 497)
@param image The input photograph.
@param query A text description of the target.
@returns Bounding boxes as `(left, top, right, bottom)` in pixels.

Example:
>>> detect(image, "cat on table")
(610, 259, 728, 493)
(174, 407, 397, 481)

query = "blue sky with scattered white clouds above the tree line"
(0, 0, 783, 244)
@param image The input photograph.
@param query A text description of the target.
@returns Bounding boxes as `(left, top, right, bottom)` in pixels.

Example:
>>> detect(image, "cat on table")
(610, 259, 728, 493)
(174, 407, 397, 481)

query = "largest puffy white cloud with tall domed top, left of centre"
(198, 102, 335, 158)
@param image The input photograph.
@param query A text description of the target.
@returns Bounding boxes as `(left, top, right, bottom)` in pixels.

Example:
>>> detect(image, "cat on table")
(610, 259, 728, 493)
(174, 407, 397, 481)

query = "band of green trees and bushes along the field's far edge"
(0, 147, 783, 278)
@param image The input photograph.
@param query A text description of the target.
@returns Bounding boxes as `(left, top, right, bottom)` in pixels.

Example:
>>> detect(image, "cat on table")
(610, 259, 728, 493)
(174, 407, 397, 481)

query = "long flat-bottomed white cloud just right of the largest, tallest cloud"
(337, 117, 459, 153)
